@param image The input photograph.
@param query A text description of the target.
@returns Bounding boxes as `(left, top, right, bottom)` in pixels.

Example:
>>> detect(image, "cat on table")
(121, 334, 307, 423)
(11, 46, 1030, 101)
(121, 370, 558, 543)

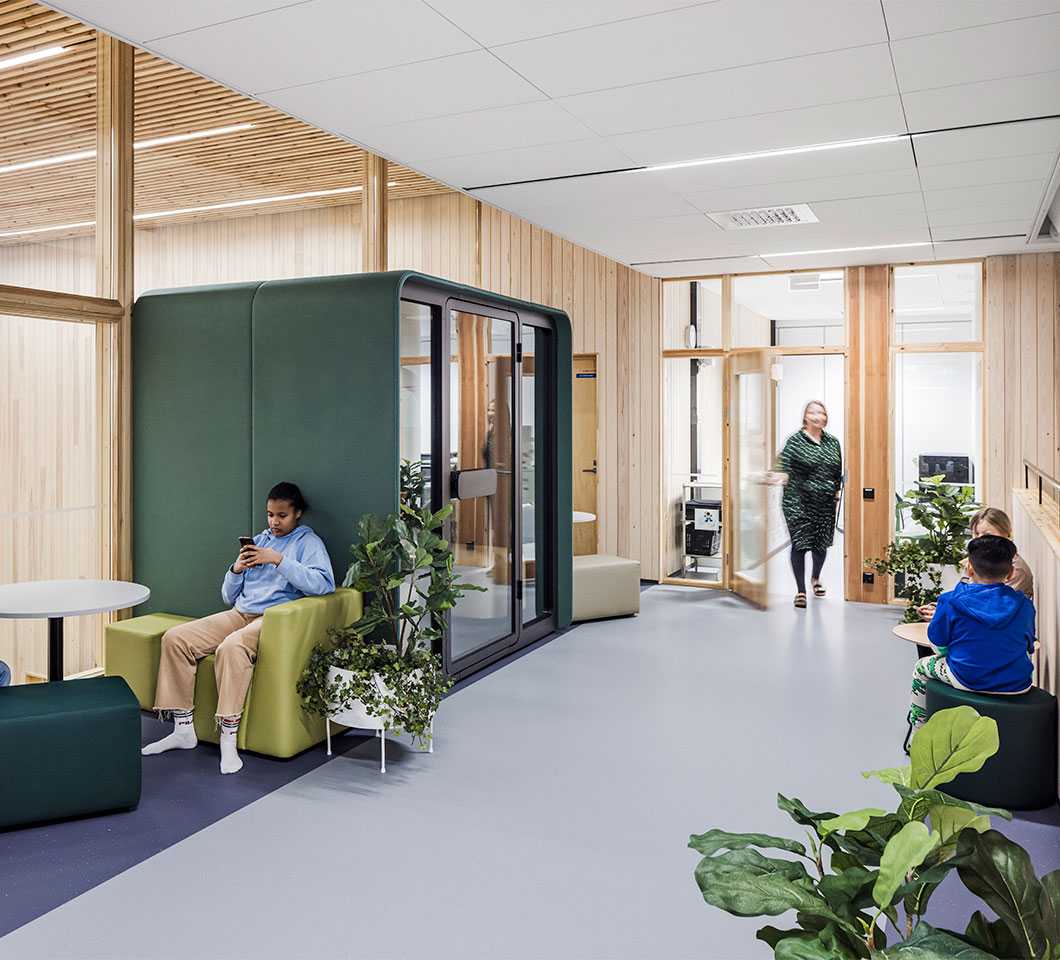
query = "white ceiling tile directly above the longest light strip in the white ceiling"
(608, 96, 905, 164)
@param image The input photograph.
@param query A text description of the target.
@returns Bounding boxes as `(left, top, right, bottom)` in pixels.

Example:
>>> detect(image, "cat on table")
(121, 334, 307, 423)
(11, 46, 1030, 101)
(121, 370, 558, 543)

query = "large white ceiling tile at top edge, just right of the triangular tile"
(494, 0, 887, 96)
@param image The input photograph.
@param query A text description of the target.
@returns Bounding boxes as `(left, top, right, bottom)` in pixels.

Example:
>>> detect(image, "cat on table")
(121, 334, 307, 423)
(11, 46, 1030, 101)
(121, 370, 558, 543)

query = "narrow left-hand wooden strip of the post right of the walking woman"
(843, 267, 865, 600)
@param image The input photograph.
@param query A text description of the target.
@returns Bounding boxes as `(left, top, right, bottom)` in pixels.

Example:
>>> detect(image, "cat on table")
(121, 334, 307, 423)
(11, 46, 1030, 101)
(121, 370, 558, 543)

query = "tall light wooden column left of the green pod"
(95, 33, 134, 580)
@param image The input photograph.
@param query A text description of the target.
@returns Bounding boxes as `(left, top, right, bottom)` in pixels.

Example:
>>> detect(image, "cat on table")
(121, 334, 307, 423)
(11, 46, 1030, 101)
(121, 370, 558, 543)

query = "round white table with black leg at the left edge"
(0, 580, 151, 680)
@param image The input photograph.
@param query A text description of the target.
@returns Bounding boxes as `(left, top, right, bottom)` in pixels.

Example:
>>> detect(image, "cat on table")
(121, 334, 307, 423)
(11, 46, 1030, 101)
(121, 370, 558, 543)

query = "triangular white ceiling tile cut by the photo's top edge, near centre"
(421, 0, 703, 47)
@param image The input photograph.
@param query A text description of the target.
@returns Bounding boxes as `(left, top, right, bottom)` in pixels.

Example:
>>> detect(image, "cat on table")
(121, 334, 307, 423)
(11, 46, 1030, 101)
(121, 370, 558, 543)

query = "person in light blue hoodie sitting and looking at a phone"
(141, 483, 335, 774)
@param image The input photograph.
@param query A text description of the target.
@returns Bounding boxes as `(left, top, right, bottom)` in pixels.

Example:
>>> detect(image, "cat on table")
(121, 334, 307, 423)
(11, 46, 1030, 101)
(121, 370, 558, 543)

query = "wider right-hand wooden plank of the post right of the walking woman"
(861, 266, 895, 603)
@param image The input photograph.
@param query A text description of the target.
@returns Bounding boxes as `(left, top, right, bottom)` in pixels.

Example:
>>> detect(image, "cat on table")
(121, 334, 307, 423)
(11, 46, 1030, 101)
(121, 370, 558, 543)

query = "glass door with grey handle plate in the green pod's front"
(445, 309, 522, 671)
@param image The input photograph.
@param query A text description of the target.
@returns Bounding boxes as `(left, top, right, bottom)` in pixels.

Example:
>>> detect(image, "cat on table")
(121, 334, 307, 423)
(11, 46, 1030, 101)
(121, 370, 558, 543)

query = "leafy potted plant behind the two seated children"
(869, 475, 979, 622)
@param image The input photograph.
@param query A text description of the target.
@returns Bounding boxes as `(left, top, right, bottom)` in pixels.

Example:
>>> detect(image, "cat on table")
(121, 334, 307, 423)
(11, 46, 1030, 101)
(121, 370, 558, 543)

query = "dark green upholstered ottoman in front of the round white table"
(0, 677, 140, 829)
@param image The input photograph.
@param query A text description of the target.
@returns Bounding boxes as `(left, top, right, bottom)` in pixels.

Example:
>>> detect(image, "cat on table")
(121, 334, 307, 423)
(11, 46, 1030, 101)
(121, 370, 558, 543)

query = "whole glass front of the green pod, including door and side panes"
(401, 288, 555, 676)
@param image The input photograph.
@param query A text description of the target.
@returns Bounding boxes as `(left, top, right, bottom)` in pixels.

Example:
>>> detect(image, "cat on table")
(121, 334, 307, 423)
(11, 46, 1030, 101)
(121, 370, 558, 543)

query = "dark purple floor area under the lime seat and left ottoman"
(0, 714, 372, 937)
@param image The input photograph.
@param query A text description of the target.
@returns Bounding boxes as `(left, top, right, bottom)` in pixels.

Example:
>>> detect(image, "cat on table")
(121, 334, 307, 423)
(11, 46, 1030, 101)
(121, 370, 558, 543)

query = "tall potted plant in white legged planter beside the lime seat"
(298, 483, 480, 770)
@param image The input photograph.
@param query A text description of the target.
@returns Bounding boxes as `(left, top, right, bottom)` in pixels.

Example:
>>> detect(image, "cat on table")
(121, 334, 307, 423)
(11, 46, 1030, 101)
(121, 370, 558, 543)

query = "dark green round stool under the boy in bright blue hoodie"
(928, 680, 1057, 810)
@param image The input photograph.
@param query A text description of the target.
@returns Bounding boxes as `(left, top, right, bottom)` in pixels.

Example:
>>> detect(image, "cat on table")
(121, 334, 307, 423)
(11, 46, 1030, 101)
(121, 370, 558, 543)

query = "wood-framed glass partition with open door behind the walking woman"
(661, 269, 847, 603)
